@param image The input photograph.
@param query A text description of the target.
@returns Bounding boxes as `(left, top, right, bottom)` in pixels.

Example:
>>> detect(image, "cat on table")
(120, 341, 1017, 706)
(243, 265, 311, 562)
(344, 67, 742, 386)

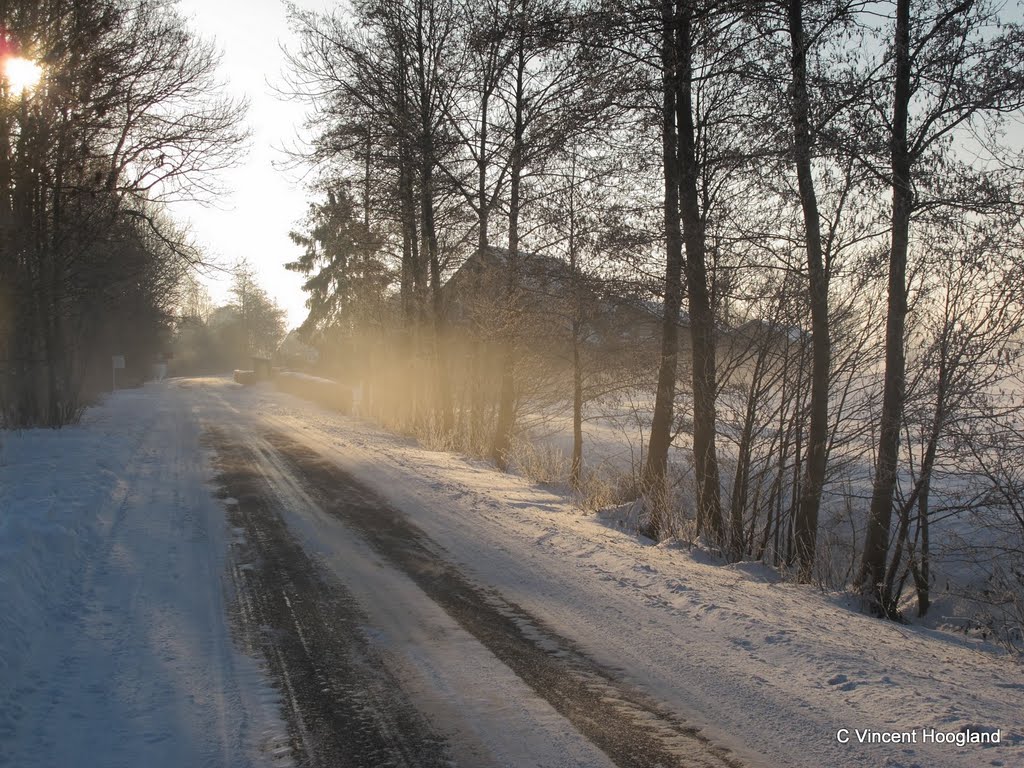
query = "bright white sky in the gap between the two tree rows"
(174, 0, 333, 328)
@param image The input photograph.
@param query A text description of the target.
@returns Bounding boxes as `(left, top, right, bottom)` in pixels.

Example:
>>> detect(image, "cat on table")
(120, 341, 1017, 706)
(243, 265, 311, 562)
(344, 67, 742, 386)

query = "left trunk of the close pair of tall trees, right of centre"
(642, 0, 683, 541)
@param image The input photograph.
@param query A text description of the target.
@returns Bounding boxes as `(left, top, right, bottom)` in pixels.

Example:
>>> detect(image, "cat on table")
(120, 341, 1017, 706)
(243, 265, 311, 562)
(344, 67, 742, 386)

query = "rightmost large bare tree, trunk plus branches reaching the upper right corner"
(856, 0, 1024, 612)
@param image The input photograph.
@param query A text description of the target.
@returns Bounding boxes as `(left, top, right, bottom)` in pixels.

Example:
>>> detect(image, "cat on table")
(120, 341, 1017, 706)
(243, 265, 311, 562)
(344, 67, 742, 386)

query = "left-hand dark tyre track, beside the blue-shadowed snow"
(207, 429, 451, 768)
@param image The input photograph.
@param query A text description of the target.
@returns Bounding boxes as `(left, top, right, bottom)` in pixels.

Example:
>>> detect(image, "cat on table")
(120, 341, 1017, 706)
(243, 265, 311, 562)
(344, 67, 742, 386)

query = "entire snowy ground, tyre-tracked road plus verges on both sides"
(0, 379, 1024, 768)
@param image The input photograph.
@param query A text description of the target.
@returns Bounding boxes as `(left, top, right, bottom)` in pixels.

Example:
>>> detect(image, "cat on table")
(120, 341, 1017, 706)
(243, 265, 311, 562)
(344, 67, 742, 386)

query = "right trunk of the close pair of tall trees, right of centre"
(676, 7, 723, 544)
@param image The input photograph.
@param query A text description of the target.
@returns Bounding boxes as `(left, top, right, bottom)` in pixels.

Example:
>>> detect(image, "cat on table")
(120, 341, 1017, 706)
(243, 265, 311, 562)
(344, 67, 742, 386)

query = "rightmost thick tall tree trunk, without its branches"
(856, 0, 913, 611)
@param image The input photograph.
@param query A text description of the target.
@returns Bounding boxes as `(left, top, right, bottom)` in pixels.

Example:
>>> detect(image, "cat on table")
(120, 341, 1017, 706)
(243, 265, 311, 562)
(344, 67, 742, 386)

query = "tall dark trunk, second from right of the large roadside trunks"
(790, 0, 831, 582)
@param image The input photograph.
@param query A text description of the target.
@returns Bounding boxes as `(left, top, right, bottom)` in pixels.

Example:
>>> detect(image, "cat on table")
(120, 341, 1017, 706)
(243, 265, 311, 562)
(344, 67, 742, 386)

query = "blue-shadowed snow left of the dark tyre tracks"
(0, 385, 286, 768)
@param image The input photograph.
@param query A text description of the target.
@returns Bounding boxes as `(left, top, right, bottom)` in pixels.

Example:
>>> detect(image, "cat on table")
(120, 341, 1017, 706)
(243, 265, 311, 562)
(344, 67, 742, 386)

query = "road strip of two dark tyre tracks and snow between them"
(210, 391, 738, 768)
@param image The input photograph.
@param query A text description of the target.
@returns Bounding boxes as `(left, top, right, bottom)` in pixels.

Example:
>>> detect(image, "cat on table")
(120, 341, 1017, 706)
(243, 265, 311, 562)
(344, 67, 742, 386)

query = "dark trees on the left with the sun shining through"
(0, 0, 245, 427)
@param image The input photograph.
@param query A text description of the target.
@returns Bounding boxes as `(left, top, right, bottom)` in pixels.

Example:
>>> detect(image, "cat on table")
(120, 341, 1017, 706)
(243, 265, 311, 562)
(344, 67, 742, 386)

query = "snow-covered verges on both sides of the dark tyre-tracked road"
(0, 379, 1024, 768)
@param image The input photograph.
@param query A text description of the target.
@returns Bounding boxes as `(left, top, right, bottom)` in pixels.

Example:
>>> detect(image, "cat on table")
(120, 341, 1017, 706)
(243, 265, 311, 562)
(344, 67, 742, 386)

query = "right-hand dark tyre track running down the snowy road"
(262, 431, 740, 768)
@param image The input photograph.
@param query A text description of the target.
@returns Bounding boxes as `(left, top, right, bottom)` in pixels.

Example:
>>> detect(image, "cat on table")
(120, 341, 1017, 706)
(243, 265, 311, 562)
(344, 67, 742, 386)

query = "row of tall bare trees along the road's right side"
(291, 0, 1024, 614)
